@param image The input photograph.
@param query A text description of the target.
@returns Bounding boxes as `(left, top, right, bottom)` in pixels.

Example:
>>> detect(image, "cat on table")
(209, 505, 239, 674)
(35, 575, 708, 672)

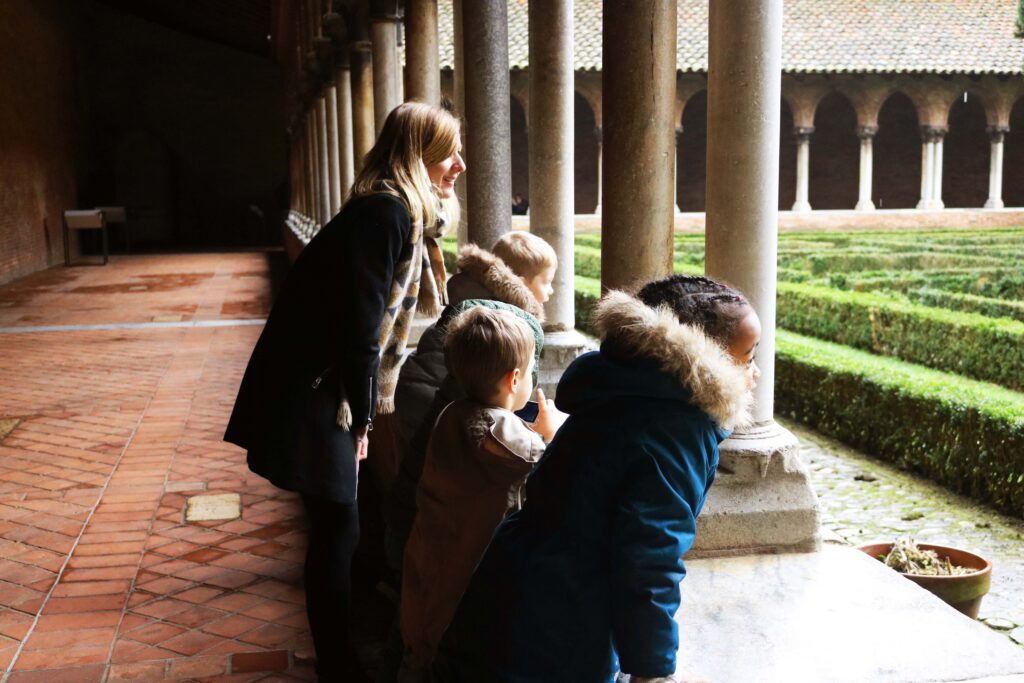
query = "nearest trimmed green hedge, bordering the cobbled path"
(775, 331, 1024, 516)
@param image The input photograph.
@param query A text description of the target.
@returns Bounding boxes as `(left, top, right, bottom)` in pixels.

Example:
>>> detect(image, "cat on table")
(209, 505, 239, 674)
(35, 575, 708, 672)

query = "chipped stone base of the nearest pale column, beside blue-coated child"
(687, 420, 821, 557)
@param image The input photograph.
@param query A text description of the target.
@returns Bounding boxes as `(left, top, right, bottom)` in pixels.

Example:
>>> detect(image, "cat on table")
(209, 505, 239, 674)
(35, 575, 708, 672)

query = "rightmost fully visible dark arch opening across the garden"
(942, 90, 989, 208)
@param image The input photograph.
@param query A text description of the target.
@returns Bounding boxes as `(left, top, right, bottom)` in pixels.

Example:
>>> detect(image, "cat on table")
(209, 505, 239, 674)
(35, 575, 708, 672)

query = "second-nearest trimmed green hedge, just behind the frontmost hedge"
(777, 283, 1024, 389)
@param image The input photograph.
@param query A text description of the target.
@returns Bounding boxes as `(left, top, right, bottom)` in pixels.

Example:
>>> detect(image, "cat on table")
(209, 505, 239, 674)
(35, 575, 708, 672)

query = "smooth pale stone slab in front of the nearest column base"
(676, 545, 1024, 683)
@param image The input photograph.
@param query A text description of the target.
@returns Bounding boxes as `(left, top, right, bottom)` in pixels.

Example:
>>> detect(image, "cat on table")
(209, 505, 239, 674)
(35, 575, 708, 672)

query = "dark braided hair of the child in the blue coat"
(636, 274, 751, 346)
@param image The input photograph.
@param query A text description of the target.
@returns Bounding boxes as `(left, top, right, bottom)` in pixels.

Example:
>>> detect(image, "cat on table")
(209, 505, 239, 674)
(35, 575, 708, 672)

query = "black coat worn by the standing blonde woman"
(224, 195, 413, 503)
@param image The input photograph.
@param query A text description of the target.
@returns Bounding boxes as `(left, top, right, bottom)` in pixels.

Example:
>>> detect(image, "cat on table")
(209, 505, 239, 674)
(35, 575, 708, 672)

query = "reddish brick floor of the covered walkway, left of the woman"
(0, 253, 313, 683)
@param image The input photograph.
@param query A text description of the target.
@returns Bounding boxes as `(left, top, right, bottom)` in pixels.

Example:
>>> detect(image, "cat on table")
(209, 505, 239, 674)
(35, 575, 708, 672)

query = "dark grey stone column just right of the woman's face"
(462, 0, 512, 249)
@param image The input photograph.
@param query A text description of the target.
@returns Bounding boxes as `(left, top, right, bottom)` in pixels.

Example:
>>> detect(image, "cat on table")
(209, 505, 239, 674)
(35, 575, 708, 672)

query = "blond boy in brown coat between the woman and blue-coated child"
(398, 306, 565, 683)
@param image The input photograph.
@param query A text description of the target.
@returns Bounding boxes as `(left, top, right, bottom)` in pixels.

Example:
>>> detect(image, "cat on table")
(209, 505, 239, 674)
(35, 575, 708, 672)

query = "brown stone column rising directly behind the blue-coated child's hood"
(601, 0, 676, 290)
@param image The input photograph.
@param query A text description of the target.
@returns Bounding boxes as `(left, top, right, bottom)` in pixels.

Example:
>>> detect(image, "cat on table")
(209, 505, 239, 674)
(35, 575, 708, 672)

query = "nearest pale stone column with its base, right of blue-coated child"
(693, 0, 819, 554)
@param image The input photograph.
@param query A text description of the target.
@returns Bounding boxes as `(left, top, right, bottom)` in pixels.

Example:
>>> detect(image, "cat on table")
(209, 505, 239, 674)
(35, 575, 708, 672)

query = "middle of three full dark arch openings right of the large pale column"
(871, 90, 921, 209)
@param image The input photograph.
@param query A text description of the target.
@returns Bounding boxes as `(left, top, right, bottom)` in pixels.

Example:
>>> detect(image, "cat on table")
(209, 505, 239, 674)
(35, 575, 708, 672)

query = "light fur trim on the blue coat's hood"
(594, 291, 754, 430)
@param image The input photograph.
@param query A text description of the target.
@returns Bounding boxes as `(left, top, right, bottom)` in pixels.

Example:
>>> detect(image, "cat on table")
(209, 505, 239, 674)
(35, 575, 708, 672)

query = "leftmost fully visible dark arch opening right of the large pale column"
(808, 91, 860, 209)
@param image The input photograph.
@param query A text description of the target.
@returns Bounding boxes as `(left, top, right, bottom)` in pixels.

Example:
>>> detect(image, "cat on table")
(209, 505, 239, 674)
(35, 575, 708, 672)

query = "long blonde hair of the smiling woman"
(348, 101, 459, 226)
